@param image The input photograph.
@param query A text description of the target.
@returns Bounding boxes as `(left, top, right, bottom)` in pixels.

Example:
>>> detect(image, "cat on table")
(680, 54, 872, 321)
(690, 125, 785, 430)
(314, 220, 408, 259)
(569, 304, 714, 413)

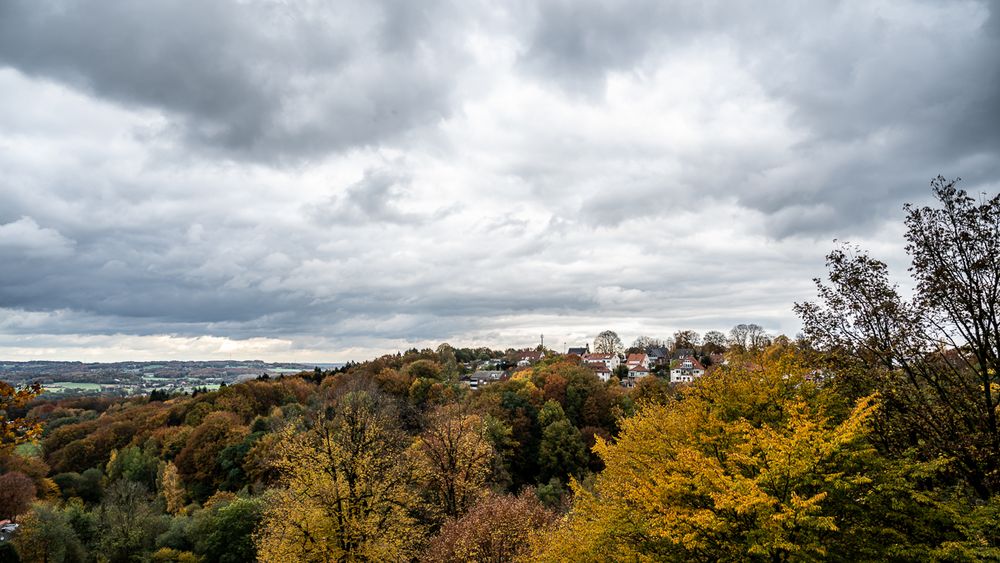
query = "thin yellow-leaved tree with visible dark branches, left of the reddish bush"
(257, 390, 424, 563)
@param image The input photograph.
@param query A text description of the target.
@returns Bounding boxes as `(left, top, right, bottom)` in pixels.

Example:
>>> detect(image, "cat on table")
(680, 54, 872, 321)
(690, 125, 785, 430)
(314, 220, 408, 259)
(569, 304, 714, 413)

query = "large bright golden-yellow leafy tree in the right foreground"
(533, 349, 940, 561)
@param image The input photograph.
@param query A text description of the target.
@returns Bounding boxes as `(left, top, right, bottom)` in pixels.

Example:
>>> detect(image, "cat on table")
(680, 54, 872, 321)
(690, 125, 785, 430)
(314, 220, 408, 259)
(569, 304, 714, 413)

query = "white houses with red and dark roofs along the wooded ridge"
(462, 345, 723, 389)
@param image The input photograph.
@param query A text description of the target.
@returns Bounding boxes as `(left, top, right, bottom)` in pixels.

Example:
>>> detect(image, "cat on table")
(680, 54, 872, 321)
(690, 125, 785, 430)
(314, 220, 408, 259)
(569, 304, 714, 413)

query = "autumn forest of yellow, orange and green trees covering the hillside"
(0, 178, 1000, 563)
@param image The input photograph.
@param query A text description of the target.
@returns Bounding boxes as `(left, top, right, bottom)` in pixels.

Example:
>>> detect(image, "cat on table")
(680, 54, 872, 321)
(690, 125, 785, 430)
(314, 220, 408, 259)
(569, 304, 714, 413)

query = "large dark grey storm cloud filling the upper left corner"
(0, 0, 461, 160)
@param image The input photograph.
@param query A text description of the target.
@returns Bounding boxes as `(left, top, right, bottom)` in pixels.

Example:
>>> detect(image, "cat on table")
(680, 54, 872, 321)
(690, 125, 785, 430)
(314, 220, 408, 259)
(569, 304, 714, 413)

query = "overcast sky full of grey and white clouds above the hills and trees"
(0, 0, 1000, 362)
